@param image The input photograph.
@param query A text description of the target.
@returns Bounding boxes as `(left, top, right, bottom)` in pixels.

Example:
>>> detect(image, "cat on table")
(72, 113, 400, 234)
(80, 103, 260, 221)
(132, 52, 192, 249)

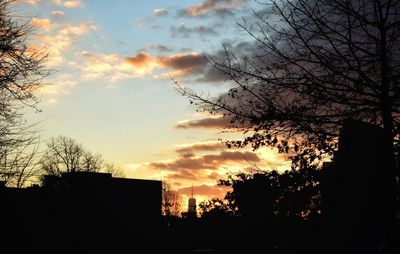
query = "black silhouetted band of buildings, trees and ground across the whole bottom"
(0, 121, 400, 254)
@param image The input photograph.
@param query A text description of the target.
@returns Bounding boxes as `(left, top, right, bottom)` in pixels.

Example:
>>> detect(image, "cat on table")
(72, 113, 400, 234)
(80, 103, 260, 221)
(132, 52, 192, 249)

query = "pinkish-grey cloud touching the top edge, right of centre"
(180, 0, 247, 17)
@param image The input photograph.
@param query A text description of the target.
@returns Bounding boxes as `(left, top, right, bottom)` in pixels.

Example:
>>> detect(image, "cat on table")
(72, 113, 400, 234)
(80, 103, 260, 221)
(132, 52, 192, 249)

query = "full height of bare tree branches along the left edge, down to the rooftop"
(0, 0, 49, 187)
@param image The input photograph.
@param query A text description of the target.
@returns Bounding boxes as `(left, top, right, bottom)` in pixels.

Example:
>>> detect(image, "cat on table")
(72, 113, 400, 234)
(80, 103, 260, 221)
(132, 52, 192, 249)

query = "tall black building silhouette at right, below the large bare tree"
(321, 120, 395, 253)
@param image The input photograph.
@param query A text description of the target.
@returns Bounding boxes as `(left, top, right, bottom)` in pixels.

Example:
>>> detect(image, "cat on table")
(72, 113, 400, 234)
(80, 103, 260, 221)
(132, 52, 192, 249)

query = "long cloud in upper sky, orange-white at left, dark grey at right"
(75, 49, 228, 83)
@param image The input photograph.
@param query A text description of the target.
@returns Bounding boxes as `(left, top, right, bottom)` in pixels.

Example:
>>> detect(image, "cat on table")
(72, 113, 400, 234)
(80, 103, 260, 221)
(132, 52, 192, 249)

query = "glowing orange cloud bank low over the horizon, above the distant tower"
(126, 141, 291, 198)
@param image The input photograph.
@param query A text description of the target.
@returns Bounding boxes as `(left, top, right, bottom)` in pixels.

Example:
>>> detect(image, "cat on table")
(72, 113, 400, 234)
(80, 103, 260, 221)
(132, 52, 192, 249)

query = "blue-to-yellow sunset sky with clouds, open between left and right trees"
(13, 0, 290, 206)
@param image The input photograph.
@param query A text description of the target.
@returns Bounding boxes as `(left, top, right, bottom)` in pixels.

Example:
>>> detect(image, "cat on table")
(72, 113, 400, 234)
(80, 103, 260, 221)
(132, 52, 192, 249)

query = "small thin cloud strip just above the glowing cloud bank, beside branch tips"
(175, 116, 230, 129)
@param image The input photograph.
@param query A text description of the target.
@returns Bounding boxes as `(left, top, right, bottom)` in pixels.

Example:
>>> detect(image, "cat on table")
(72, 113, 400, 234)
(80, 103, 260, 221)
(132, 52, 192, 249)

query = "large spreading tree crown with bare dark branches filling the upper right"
(175, 0, 400, 159)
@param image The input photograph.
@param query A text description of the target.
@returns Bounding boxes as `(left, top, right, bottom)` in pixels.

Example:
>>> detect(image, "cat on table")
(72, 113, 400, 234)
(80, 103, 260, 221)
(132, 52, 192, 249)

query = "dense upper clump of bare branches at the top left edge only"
(0, 0, 49, 111)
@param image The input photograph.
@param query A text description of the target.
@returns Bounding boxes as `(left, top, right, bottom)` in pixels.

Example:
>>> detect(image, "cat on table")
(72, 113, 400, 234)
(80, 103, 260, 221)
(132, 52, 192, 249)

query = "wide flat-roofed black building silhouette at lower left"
(0, 172, 161, 253)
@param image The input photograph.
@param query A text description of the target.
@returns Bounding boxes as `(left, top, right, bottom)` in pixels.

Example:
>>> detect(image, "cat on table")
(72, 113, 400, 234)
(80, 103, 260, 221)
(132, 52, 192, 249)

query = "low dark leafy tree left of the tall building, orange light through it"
(218, 168, 321, 218)
